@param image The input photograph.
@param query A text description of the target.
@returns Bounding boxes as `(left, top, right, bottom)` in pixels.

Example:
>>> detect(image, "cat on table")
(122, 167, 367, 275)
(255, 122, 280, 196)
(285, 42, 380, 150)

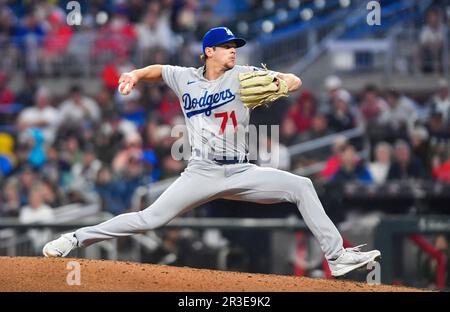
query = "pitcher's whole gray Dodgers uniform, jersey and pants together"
(75, 65, 343, 259)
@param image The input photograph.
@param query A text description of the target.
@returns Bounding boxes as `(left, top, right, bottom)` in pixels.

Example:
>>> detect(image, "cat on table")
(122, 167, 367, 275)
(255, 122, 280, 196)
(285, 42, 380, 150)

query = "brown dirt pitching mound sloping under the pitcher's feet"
(0, 257, 417, 292)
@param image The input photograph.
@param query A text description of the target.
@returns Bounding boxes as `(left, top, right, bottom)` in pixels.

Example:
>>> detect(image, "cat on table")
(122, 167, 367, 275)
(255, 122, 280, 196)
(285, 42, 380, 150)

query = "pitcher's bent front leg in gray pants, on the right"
(225, 165, 343, 259)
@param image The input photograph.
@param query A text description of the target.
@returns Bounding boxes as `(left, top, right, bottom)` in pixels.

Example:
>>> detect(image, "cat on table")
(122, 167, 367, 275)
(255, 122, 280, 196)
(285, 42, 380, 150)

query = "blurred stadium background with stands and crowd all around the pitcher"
(0, 0, 450, 289)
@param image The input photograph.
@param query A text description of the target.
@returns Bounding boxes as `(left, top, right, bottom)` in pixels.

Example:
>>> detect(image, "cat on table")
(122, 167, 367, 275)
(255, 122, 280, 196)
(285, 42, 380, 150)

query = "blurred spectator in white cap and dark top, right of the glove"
(328, 89, 356, 132)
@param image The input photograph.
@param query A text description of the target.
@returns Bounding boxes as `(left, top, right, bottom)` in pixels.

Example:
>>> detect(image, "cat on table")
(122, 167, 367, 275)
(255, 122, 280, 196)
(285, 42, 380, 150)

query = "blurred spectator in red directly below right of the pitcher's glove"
(286, 90, 316, 134)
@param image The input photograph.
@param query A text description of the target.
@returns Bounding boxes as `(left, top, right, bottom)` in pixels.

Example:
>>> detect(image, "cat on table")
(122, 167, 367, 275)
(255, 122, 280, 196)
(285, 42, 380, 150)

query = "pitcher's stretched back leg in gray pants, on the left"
(75, 166, 220, 247)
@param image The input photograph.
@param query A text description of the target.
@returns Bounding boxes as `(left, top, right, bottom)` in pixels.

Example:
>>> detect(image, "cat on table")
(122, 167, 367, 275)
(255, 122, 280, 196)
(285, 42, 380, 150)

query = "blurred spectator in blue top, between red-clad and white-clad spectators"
(331, 145, 373, 184)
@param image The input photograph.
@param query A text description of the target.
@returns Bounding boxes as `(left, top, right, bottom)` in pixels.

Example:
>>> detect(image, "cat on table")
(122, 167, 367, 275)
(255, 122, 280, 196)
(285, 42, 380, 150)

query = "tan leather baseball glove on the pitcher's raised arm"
(239, 65, 288, 108)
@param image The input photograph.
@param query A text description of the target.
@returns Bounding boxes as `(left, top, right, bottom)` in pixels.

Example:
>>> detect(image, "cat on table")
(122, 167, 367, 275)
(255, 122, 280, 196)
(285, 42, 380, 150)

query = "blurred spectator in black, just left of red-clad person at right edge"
(387, 140, 426, 180)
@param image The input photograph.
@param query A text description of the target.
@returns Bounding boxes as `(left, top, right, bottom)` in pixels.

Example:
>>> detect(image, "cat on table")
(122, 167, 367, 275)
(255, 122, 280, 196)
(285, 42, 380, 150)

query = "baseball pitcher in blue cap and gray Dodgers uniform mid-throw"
(43, 27, 380, 276)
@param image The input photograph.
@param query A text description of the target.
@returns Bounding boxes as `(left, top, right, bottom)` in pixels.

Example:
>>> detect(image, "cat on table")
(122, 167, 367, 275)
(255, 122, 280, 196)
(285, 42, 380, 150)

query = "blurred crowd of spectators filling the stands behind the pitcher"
(0, 0, 450, 222)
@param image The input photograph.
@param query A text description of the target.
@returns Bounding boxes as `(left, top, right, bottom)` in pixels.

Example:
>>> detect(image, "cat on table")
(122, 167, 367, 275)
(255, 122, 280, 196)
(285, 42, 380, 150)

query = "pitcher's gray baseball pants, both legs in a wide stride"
(75, 160, 343, 259)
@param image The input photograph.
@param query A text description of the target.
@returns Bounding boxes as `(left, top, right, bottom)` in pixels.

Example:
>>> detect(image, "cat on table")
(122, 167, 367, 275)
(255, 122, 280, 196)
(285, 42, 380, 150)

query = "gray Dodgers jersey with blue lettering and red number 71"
(162, 65, 278, 158)
